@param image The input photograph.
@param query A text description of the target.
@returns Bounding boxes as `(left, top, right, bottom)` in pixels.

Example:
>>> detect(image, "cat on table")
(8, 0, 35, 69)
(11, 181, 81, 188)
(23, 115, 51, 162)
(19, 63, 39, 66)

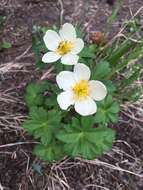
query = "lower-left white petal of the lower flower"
(57, 91, 74, 110)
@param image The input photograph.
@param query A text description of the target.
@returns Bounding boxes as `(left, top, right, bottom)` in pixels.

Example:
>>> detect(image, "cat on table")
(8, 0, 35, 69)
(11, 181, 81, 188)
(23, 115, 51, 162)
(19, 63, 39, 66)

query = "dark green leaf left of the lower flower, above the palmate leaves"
(25, 81, 49, 108)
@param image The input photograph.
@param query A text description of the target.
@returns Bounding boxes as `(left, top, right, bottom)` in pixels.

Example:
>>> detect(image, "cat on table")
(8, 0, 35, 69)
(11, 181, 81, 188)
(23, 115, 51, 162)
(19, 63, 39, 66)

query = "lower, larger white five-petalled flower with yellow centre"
(56, 63, 107, 116)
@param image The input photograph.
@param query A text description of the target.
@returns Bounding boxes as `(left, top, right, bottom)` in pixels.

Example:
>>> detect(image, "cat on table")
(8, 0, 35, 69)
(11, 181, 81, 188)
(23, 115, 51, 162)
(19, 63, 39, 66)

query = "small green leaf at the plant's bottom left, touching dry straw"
(33, 142, 64, 162)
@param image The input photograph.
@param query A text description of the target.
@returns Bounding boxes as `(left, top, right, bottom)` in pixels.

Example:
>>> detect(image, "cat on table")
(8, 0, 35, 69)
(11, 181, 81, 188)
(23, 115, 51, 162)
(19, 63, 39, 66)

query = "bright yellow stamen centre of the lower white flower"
(73, 80, 90, 100)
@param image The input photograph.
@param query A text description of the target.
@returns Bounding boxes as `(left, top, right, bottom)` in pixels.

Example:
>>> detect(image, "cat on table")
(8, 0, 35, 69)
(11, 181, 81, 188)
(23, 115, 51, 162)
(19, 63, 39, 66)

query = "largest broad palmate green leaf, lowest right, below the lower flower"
(56, 117, 115, 159)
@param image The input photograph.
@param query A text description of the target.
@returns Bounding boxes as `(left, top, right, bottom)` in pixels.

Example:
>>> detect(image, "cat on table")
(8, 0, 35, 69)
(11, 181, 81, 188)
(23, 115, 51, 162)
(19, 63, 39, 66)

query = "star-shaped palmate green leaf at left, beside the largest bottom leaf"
(23, 107, 61, 145)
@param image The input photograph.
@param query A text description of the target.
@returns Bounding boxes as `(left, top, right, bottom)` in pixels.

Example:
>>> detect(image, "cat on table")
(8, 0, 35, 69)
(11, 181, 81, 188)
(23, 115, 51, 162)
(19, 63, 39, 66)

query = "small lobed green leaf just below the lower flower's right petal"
(95, 95, 120, 125)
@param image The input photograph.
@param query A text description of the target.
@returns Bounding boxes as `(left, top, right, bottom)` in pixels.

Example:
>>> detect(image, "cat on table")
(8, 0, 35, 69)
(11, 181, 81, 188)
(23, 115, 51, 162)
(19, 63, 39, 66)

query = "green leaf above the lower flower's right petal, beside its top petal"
(91, 61, 111, 80)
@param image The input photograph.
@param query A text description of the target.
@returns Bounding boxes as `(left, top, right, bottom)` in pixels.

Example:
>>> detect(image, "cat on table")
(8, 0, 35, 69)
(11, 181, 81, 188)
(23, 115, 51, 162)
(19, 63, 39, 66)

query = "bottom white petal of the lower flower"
(74, 98, 97, 116)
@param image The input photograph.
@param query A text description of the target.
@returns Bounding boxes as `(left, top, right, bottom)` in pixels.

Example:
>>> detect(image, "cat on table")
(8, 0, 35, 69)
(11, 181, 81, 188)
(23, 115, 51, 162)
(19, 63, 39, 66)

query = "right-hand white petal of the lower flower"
(89, 80, 107, 101)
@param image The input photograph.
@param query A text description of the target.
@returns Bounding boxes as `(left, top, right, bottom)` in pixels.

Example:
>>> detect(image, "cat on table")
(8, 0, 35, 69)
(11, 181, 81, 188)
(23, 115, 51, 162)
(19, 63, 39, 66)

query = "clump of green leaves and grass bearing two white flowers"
(23, 23, 143, 162)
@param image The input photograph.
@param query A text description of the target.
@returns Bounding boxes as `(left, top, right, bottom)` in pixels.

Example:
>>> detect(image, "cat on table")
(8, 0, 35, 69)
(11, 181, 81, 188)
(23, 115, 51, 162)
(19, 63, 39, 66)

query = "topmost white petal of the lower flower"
(74, 63, 91, 80)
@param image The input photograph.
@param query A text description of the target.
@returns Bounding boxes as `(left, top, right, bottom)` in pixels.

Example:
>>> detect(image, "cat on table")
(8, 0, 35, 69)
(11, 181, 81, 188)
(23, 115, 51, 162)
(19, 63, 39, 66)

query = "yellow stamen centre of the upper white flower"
(57, 41, 73, 55)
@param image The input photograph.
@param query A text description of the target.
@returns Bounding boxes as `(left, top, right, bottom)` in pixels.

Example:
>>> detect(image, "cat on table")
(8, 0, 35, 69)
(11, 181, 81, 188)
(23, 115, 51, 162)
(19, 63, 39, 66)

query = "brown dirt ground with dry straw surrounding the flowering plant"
(0, 0, 143, 190)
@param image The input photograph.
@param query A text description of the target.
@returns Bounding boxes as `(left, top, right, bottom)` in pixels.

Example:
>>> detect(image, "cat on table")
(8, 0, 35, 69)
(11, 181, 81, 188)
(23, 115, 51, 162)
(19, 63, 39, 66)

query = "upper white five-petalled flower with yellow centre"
(42, 23, 84, 65)
